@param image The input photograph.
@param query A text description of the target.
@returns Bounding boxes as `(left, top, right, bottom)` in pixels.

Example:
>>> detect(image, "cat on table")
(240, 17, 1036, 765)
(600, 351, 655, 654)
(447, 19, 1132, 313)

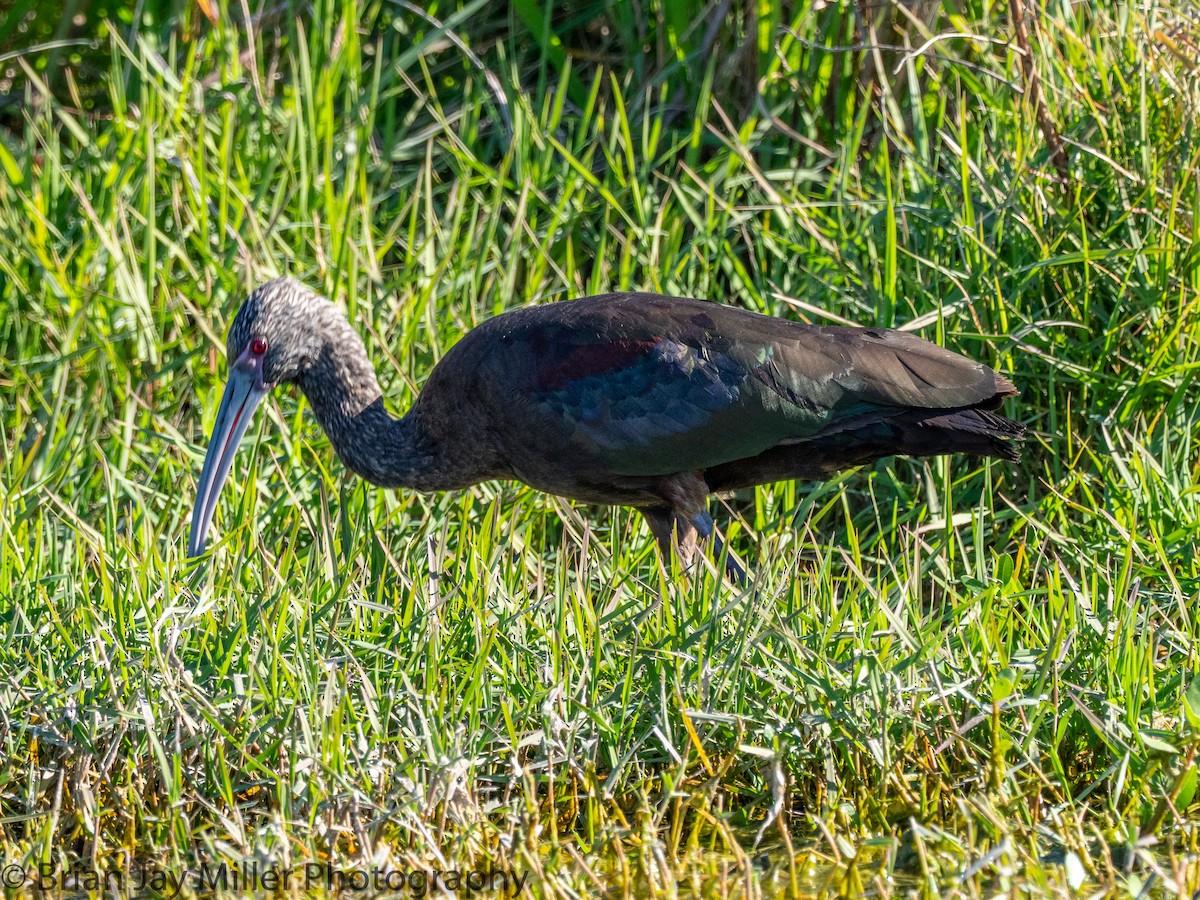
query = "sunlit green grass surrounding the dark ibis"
(0, 0, 1200, 896)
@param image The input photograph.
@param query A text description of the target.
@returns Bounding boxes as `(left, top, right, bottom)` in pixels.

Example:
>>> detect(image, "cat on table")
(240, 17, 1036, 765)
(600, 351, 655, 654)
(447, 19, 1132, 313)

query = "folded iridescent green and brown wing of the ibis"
(472, 295, 1015, 475)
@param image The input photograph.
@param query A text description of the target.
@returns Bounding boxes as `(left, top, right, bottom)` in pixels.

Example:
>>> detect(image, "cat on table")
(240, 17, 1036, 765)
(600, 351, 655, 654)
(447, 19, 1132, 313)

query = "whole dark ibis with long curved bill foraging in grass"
(188, 278, 1024, 573)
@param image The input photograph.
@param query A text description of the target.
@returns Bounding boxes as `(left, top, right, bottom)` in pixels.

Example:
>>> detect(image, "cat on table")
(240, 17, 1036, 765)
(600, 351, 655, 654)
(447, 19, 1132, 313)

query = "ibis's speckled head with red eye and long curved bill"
(187, 278, 346, 556)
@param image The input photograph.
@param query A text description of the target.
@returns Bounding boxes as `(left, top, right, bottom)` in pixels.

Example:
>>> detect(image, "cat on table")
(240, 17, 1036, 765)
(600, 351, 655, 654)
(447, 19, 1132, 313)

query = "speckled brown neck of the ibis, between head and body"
(296, 324, 431, 490)
